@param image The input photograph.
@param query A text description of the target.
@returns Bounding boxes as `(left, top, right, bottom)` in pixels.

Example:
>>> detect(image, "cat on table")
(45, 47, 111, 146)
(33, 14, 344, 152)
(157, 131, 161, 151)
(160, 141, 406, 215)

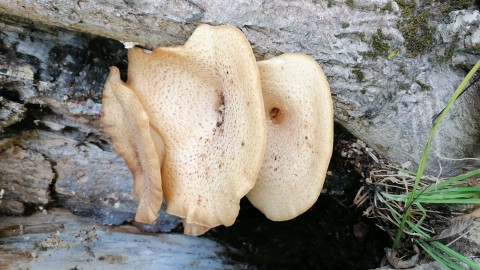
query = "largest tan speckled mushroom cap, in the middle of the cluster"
(127, 25, 266, 232)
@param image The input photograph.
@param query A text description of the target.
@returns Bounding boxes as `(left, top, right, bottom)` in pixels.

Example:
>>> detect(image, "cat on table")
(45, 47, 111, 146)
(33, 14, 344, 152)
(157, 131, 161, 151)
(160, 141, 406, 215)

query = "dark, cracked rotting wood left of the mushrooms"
(0, 15, 134, 219)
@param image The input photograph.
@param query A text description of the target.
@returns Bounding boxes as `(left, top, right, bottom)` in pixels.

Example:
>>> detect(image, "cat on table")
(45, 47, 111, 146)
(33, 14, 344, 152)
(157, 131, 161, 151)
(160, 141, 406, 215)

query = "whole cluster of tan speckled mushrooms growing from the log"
(102, 25, 333, 235)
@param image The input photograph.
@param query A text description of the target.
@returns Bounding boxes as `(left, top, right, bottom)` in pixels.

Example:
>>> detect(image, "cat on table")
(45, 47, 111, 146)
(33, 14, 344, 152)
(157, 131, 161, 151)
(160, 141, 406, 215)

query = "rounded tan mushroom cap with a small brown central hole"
(247, 54, 333, 221)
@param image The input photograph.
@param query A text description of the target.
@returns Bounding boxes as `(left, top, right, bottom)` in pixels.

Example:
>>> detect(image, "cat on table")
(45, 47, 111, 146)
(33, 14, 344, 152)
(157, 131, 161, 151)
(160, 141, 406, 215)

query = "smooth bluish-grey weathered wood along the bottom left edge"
(0, 209, 246, 270)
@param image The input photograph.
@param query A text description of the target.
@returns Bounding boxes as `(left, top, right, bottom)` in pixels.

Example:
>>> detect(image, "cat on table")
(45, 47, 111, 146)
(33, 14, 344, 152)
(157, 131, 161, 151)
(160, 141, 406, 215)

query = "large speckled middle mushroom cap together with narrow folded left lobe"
(102, 25, 266, 235)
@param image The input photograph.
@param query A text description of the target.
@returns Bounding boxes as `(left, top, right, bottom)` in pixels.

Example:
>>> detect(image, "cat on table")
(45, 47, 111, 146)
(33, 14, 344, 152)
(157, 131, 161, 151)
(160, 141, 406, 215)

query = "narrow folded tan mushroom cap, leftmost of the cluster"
(102, 67, 165, 223)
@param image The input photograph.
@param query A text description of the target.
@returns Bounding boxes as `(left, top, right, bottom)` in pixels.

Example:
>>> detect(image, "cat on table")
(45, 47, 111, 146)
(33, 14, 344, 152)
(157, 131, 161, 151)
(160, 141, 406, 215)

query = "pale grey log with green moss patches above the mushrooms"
(0, 0, 480, 174)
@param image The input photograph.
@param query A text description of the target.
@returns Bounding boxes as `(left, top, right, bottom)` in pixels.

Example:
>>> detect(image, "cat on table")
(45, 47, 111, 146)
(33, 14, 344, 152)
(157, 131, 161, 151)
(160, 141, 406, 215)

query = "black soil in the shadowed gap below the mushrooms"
(205, 127, 391, 269)
